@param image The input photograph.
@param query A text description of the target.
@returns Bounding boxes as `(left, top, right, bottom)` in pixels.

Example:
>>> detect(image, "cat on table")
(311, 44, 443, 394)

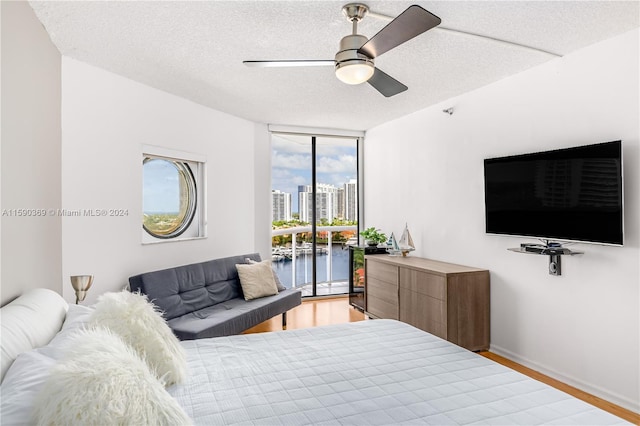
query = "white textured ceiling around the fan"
(30, 0, 640, 130)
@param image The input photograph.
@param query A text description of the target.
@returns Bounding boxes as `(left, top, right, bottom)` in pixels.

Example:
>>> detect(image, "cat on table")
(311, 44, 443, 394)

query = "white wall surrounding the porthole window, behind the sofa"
(62, 57, 269, 303)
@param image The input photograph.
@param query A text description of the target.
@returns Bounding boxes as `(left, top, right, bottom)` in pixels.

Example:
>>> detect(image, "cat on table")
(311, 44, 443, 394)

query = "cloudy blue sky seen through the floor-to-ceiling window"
(271, 135, 358, 213)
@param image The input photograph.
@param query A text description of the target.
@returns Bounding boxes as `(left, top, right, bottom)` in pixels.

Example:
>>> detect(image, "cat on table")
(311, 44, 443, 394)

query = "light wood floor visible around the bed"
(245, 297, 640, 425)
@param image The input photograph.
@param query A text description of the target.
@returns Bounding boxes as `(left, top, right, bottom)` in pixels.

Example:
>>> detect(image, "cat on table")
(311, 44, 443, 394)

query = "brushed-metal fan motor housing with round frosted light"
(335, 34, 375, 84)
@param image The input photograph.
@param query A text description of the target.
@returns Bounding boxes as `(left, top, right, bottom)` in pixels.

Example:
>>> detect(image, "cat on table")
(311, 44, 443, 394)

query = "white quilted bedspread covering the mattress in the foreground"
(169, 320, 628, 425)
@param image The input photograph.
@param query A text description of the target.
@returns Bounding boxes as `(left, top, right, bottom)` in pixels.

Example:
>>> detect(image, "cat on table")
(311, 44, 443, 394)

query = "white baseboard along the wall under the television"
(490, 344, 640, 413)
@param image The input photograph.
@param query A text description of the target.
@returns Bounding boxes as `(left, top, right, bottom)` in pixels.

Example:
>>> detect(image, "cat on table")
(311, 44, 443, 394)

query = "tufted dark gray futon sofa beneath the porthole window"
(129, 253, 301, 340)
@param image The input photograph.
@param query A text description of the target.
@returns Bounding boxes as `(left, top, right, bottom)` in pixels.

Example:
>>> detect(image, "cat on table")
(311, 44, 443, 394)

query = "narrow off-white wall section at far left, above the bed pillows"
(0, 1, 62, 304)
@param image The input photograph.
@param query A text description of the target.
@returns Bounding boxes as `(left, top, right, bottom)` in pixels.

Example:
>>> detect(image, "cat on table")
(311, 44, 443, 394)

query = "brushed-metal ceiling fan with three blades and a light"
(243, 3, 441, 97)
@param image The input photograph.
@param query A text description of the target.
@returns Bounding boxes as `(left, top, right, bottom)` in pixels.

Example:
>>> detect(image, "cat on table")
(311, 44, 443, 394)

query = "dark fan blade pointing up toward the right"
(358, 4, 442, 58)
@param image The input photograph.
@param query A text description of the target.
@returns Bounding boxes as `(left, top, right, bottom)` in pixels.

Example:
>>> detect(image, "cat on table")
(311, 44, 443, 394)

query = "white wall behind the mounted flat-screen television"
(365, 30, 640, 412)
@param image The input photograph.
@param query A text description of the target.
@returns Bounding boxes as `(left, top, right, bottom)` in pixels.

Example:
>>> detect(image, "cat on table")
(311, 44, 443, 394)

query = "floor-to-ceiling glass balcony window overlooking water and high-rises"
(271, 133, 359, 296)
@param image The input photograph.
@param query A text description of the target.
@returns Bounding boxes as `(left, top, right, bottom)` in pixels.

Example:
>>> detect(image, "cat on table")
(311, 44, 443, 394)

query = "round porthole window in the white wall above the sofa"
(142, 157, 197, 239)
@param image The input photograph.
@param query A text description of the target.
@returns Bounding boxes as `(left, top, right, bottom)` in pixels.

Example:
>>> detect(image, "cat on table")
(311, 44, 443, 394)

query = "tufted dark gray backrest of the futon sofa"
(129, 253, 260, 320)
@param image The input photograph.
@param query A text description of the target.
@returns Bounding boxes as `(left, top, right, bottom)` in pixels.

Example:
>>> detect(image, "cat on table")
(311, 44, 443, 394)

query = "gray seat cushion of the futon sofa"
(168, 289, 302, 340)
